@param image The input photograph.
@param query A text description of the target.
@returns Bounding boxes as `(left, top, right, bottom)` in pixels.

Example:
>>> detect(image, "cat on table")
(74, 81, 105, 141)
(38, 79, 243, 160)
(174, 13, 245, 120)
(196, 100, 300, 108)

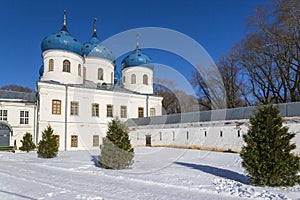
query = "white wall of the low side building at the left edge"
(0, 100, 36, 148)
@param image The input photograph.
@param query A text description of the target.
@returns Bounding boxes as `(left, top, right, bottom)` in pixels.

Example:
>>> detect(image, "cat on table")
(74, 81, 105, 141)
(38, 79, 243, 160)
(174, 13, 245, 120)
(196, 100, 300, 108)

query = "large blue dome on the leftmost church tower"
(41, 26, 83, 56)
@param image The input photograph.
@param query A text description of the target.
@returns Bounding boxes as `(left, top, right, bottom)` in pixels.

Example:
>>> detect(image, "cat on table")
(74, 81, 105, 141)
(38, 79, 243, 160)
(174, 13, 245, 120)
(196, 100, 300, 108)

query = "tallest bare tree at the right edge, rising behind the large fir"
(238, 0, 300, 104)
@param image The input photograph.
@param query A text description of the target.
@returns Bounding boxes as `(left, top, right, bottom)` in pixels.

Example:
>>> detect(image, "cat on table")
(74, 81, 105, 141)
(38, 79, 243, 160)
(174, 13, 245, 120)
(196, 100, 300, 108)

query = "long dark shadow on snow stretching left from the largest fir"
(175, 162, 250, 184)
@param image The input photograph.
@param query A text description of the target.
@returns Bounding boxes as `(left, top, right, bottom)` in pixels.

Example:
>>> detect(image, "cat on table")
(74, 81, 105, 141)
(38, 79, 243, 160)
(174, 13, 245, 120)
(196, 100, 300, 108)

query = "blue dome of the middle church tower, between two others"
(83, 33, 115, 61)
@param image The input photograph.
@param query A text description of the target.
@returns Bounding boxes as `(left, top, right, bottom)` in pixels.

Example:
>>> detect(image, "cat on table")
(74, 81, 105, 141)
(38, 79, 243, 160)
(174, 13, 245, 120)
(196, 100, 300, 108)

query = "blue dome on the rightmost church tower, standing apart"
(121, 48, 153, 69)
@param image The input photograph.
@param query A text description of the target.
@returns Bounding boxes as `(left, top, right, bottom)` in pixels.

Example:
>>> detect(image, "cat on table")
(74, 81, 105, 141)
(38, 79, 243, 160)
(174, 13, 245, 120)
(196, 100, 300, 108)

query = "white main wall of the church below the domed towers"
(38, 82, 162, 150)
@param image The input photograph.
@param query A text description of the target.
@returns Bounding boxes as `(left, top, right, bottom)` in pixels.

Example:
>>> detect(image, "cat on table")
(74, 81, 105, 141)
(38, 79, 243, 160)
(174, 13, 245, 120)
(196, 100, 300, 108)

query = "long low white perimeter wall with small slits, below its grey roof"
(129, 117, 300, 154)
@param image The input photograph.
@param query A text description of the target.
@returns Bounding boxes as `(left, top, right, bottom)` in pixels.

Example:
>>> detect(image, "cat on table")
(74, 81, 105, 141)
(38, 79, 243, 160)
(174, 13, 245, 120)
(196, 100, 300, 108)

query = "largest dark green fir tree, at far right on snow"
(241, 105, 300, 186)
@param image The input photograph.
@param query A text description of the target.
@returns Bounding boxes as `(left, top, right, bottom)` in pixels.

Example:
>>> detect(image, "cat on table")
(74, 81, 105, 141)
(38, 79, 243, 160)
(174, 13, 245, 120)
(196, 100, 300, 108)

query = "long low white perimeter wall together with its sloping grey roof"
(126, 102, 300, 155)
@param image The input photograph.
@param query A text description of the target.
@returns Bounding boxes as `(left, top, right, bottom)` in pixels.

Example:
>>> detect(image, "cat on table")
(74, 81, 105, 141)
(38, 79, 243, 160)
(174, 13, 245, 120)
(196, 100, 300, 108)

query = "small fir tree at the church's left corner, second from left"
(37, 125, 58, 158)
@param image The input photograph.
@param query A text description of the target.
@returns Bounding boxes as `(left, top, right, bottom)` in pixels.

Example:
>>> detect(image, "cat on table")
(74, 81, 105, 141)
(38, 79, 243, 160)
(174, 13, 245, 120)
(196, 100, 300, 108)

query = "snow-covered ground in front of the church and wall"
(0, 147, 300, 200)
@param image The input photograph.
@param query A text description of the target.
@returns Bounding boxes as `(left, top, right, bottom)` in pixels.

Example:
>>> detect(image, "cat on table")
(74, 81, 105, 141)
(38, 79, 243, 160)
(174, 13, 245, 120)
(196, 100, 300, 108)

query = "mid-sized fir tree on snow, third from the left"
(98, 119, 134, 169)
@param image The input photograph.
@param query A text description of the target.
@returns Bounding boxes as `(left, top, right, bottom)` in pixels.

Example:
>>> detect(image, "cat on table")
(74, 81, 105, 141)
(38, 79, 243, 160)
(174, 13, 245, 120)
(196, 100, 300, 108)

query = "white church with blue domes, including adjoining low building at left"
(0, 14, 163, 150)
